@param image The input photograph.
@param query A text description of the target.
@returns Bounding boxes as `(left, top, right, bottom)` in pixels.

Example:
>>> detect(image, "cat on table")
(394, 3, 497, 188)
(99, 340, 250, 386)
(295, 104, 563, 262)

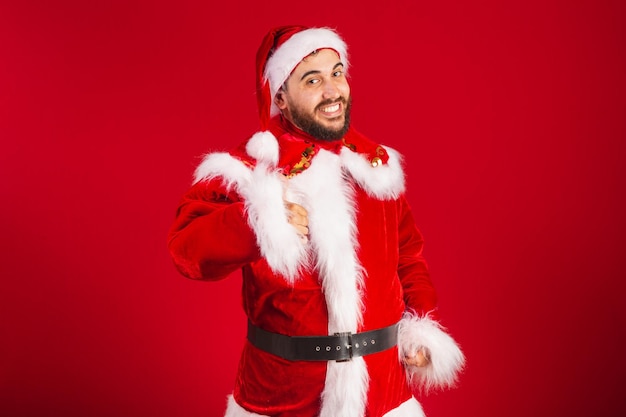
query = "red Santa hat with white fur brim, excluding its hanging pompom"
(256, 26, 348, 130)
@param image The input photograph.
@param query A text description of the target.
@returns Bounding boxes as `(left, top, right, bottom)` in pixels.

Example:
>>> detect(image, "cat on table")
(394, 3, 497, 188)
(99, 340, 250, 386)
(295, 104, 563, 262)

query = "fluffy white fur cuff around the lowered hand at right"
(398, 312, 465, 391)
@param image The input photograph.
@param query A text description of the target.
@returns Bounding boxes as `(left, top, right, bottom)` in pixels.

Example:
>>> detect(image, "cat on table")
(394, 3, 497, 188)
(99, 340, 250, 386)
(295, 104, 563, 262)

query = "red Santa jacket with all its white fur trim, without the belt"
(169, 116, 464, 417)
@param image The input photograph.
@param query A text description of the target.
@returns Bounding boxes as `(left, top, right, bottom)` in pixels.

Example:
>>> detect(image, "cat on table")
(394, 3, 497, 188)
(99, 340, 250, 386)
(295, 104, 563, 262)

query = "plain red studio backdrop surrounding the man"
(0, 0, 626, 417)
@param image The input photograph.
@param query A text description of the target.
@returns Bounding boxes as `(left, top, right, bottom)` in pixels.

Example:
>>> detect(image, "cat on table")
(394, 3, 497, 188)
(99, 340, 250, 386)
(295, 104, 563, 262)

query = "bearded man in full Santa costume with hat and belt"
(169, 26, 464, 417)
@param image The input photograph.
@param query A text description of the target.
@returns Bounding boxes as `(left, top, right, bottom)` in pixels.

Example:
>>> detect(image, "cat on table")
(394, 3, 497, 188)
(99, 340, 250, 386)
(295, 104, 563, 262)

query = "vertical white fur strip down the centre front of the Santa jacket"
(287, 150, 372, 417)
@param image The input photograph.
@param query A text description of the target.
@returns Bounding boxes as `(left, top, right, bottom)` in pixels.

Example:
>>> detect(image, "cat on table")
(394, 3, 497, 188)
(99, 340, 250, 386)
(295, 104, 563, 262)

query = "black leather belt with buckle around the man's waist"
(248, 321, 398, 361)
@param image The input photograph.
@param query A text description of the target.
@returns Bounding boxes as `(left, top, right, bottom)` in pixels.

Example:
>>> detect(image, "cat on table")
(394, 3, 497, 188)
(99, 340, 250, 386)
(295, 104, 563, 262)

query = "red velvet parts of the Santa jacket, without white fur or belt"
(170, 118, 436, 417)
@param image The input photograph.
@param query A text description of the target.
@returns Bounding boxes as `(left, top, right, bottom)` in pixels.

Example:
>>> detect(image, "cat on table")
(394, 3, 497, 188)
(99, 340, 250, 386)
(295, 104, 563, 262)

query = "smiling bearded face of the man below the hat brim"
(274, 49, 351, 140)
